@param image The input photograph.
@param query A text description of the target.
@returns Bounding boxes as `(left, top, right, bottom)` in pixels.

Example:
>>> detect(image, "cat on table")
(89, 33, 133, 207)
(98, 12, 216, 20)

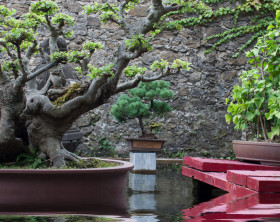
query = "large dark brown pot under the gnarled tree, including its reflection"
(0, 160, 133, 215)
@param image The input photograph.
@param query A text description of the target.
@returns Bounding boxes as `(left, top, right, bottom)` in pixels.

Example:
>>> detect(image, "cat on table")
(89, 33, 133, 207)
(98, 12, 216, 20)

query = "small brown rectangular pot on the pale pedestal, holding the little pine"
(126, 138, 166, 152)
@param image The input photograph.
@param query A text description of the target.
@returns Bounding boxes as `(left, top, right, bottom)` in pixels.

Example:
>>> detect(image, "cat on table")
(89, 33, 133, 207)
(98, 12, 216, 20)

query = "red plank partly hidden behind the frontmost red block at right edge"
(227, 170, 280, 186)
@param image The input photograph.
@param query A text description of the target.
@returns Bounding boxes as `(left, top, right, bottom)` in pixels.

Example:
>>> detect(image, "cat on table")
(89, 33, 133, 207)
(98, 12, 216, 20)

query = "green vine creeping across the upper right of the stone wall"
(159, 0, 280, 57)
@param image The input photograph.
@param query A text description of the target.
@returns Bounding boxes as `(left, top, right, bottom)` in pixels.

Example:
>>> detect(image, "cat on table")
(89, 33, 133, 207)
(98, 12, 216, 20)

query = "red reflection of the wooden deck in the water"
(183, 193, 280, 222)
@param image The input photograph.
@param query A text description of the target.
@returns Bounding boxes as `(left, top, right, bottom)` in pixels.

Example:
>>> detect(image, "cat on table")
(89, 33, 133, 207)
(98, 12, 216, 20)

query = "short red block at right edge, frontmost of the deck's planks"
(247, 177, 280, 193)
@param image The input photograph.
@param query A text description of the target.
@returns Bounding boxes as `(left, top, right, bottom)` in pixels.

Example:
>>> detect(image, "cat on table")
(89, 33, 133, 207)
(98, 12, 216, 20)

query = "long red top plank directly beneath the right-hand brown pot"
(183, 157, 280, 172)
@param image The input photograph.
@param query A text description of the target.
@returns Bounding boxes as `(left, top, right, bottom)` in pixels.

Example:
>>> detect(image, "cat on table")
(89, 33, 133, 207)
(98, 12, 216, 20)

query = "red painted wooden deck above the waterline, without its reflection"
(182, 157, 280, 195)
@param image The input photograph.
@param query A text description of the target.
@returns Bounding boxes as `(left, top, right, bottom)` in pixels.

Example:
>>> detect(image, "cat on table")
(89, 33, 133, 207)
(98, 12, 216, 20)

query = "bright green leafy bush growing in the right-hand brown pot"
(225, 11, 280, 141)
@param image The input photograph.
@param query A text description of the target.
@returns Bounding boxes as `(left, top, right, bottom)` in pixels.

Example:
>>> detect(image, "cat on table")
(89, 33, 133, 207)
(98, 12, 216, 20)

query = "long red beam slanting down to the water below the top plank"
(182, 166, 256, 198)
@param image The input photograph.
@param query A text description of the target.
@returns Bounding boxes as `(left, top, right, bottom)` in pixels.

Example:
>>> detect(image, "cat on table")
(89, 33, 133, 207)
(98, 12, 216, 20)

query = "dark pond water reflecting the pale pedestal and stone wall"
(0, 162, 223, 222)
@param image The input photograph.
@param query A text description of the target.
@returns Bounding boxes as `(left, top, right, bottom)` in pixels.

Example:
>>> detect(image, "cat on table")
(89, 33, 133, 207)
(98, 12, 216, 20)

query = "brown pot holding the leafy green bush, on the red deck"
(232, 140, 280, 166)
